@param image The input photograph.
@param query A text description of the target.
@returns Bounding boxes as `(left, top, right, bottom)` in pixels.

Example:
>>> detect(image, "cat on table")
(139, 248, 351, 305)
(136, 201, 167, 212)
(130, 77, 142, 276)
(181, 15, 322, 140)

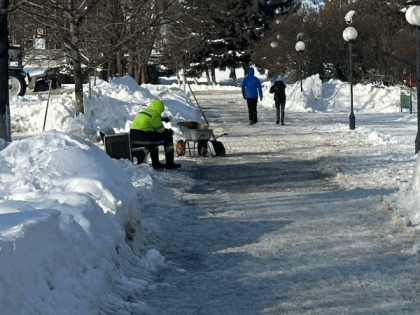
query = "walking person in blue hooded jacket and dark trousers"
(242, 68, 262, 125)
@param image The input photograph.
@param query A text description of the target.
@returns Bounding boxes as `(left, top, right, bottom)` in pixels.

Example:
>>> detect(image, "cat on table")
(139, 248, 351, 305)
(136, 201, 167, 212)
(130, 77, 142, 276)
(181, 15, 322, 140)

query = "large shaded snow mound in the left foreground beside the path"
(0, 131, 159, 314)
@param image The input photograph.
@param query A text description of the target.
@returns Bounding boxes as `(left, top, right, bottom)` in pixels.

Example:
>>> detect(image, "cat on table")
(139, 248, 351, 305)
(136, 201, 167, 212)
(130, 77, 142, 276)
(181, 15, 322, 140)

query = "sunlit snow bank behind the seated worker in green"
(10, 76, 203, 140)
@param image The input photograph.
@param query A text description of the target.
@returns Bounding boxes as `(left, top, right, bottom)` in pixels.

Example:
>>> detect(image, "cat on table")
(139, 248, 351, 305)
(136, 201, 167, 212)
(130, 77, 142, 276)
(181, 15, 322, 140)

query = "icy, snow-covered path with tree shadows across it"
(139, 91, 420, 315)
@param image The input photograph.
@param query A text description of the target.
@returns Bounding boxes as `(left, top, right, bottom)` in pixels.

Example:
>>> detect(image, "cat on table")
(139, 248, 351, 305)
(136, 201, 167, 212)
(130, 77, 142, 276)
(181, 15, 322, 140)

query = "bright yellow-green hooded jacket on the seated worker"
(130, 100, 165, 133)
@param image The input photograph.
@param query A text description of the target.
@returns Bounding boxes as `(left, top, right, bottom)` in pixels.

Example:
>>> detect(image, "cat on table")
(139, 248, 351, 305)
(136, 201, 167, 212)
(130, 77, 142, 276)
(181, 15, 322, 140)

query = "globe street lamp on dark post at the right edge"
(405, 1, 420, 154)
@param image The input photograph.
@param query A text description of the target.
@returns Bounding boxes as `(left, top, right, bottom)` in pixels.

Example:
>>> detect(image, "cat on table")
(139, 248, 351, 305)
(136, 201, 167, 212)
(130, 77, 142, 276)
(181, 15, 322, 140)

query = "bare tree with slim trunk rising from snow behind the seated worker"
(14, 0, 175, 115)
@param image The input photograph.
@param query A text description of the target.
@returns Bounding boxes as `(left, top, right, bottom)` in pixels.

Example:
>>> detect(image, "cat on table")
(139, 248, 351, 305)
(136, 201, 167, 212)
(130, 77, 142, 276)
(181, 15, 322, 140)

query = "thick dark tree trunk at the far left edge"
(0, 0, 11, 142)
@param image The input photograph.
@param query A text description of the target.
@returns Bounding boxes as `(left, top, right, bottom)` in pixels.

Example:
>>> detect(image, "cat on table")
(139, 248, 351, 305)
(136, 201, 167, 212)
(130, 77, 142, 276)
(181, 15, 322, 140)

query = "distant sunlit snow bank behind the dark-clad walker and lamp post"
(261, 75, 401, 114)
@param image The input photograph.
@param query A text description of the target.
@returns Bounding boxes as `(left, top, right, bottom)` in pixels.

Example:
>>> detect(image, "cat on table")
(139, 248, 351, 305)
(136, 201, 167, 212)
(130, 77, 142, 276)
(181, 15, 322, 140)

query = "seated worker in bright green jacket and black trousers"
(130, 100, 181, 170)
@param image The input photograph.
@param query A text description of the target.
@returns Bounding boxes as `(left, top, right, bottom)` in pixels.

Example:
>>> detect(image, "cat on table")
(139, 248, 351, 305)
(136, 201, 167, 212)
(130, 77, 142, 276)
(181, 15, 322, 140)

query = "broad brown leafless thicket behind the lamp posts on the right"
(256, 0, 415, 83)
